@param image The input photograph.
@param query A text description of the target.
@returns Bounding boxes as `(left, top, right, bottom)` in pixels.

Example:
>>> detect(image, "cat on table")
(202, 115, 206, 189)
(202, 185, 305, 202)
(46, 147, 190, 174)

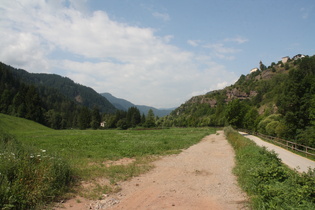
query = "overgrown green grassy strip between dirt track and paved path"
(224, 127, 315, 209)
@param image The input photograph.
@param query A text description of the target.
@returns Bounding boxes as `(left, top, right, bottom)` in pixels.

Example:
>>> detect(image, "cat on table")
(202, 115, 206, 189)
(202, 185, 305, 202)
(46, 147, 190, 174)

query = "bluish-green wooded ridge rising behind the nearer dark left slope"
(11, 68, 116, 113)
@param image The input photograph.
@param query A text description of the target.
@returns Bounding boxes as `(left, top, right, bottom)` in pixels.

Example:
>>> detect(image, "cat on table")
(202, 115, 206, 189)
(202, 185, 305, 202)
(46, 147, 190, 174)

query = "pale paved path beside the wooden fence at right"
(239, 132, 315, 173)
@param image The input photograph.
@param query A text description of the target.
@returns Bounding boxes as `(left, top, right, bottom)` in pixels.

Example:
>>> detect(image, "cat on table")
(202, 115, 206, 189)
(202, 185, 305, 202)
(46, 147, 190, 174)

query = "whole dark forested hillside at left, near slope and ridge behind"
(0, 63, 115, 129)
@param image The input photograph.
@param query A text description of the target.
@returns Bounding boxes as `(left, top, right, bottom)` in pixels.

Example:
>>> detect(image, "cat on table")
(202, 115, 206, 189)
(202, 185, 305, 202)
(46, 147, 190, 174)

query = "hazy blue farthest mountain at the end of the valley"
(101, 93, 175, 117)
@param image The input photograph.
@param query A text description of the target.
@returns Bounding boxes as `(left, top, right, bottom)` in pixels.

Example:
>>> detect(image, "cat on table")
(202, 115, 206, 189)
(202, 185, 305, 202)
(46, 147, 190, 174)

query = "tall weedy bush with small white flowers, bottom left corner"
(0, 133, 73, 209)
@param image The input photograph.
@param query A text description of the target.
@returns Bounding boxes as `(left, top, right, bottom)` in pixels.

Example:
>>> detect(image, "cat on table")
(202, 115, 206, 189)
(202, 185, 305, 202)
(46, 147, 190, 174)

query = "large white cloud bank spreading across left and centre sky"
(0, 0, 238, 107)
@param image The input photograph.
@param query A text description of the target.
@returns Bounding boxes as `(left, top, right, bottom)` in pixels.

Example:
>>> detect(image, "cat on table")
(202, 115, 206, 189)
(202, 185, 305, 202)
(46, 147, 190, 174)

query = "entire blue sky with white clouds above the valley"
(0, 0, 315, 108)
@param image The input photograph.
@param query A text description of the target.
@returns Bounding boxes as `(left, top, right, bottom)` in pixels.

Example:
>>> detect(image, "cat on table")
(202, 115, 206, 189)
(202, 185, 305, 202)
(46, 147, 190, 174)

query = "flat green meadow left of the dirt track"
(0, 114, 215, 207)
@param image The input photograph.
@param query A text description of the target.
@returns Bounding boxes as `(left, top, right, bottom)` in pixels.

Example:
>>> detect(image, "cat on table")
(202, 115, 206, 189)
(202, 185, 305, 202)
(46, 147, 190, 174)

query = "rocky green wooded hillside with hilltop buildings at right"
(158, 56, 315, 147)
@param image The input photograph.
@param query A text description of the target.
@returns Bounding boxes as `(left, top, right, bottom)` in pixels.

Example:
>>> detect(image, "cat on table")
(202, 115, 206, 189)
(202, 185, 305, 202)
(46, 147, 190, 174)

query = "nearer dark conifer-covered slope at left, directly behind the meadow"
(0, 63, 101, 129)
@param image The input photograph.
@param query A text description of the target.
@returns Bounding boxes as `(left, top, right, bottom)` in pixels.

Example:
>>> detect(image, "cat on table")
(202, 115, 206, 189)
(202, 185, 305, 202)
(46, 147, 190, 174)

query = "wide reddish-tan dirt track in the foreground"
(54, 131, 247, 210)
